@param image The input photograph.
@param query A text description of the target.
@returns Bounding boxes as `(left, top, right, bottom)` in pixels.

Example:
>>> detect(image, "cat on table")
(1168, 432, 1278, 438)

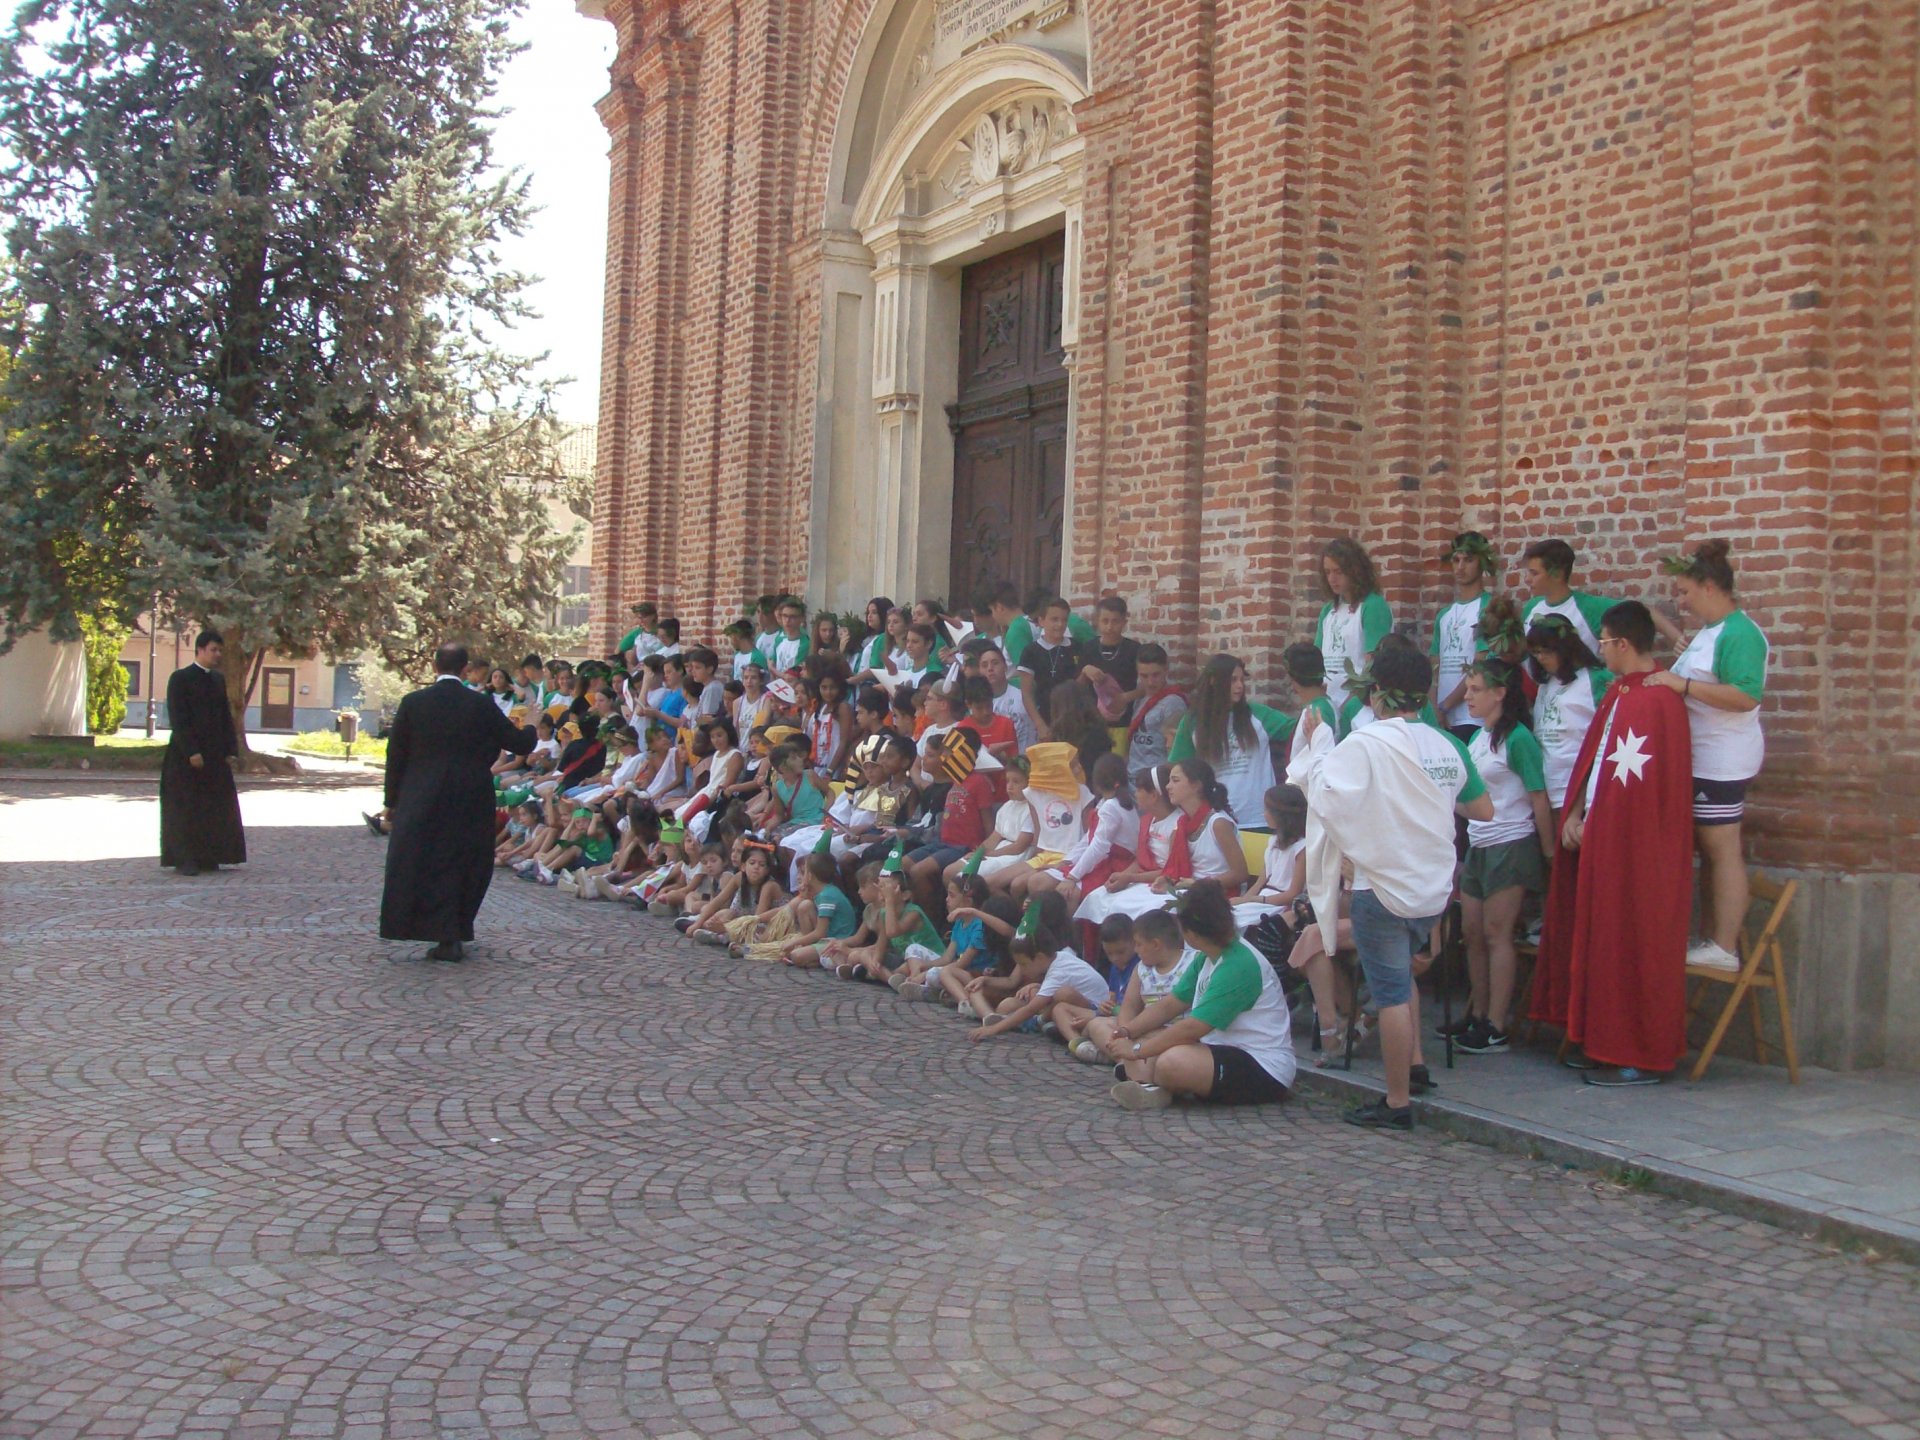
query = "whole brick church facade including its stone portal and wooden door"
(580, 0, 1920, 1066)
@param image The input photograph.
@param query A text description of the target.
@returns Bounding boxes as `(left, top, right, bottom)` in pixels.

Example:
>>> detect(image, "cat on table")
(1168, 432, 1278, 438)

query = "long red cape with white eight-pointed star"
(1528, 674, 1693, 1069)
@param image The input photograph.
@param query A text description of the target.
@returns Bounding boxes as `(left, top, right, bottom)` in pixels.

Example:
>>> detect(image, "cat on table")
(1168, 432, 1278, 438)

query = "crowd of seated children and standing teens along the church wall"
(472, 532, 1764, 1125)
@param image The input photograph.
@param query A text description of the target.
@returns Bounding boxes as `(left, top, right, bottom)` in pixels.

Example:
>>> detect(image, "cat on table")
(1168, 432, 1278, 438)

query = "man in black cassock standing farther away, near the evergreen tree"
(159, 630, 246, 876)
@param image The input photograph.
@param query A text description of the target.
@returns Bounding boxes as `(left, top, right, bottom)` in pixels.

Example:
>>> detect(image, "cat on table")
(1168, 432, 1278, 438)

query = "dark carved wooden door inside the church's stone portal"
(947, 234, 1068, 609)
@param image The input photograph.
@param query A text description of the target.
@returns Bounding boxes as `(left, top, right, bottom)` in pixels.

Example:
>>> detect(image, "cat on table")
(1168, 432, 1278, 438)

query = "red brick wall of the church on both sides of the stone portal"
(595, 0, 1920, 872)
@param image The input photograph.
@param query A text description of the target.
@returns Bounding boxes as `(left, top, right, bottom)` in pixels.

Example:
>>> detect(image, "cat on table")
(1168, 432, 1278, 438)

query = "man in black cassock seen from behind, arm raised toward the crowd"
(380, 645, 538, 960)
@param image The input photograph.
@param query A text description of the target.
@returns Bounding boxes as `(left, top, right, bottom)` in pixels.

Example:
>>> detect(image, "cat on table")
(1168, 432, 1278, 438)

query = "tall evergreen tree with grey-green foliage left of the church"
(0, 0, 570, 760)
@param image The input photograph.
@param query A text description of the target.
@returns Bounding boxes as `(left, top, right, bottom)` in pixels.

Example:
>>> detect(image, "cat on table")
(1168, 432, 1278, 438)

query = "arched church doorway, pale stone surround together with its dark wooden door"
(808, 0, 1087, 609)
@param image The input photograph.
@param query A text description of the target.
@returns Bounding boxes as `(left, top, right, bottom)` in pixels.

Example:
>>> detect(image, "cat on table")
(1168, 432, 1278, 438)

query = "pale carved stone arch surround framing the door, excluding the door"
(808, 0, 1087, 609)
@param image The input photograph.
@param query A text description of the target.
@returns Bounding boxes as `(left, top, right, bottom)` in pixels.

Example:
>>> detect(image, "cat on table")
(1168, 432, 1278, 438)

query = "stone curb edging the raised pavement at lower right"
(1296, 1068, 1920, 1265)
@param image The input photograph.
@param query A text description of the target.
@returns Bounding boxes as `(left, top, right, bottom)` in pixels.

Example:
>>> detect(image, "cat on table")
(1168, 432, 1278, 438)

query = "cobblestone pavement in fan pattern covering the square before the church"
(0, 785, 1920, 1440)
